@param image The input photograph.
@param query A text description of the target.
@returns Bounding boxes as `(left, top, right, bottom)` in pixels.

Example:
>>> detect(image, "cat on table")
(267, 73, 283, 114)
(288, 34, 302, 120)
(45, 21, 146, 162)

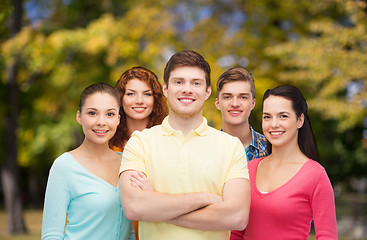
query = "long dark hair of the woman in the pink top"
(263, 85, 319, 161)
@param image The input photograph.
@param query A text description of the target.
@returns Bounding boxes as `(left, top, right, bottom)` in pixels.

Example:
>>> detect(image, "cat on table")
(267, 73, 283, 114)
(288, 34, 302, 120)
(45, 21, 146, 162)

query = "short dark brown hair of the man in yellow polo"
(163, 50, 210, 88)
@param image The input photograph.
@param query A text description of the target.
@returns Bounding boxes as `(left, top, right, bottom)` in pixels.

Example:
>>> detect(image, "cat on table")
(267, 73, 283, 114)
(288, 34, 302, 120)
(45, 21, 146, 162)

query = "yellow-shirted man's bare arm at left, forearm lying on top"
(119, 170, 221, 222)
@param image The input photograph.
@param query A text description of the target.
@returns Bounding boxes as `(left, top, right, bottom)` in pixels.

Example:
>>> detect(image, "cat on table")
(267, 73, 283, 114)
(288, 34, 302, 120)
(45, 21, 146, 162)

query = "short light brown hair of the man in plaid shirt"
(217, 67, 255, 99)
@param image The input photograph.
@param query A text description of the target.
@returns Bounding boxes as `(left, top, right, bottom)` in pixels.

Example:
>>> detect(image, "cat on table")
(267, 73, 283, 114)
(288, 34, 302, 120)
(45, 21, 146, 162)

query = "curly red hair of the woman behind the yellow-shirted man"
(109, 66, 168, 151)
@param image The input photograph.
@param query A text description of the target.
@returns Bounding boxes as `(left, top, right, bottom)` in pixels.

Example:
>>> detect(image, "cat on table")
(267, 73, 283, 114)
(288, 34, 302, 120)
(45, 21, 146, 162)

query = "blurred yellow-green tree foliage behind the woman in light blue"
(1, 0, 178, 217)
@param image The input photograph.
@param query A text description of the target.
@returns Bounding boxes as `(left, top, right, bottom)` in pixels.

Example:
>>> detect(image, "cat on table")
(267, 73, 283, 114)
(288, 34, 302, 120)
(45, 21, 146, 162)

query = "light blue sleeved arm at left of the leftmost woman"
(42, 159, 70, 240)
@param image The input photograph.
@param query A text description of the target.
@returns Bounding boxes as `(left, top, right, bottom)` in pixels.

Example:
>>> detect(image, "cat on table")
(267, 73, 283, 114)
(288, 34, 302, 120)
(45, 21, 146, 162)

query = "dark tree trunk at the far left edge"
(1, 0, 26, 234)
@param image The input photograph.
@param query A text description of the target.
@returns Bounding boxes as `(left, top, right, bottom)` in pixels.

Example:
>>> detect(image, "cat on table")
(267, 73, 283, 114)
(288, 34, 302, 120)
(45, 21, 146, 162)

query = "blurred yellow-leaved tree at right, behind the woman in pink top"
(265, 0, 367, 181)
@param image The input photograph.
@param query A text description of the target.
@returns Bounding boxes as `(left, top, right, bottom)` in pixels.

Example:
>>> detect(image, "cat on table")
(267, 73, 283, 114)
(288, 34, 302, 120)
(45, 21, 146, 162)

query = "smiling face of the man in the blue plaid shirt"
(215, 81, 255, 125)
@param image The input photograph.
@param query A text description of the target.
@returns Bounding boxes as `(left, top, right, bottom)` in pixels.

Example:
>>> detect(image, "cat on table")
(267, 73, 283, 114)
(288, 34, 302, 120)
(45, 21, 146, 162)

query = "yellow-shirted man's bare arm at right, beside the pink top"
(168, 178, 251, 231)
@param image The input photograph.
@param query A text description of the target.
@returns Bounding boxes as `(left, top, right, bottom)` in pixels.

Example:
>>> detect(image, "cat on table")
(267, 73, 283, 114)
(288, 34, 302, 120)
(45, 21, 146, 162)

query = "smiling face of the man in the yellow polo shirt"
(163, 66, 211, 118)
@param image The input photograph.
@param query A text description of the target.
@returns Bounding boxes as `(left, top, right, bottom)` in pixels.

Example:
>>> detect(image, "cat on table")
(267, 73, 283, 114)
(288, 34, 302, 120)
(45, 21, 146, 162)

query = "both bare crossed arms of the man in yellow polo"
(119, 170, 250, 231)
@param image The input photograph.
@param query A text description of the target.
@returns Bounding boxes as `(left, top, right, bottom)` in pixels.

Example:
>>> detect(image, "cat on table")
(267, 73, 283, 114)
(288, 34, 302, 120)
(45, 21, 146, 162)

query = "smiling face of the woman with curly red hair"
(122, 78, 154, 123)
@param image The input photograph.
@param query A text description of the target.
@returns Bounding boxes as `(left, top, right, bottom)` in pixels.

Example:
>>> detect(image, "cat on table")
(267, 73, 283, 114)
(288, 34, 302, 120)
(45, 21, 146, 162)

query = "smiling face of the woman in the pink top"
(262, 96, 304, 148)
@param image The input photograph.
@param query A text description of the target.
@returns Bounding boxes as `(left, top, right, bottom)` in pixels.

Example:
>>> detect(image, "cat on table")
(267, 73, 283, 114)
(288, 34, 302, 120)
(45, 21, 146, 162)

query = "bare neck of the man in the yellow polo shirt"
(168, 114, 203, 136)
